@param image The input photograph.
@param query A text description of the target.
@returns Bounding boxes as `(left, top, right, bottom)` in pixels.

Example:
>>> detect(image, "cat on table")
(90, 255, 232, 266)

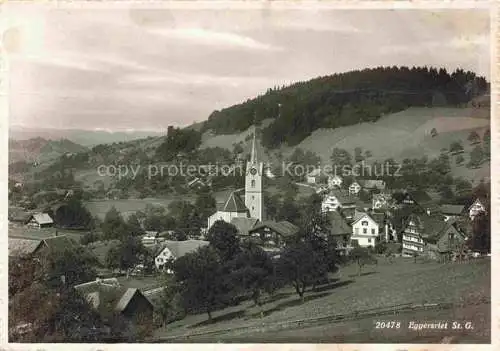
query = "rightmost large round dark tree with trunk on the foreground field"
(277, 242, 328, 302)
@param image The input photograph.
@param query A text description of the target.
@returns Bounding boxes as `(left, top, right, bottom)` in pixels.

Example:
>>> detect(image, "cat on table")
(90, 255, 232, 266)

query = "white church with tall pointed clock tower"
(207, 132, 264, 229)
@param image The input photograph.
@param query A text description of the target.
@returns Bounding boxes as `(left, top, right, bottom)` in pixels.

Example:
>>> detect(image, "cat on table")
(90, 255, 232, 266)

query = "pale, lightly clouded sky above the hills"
(0, 8, 490, 131)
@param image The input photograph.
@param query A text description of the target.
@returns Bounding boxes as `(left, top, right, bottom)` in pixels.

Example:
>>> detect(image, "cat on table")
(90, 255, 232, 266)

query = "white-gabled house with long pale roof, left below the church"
(151, 240, 209, 272)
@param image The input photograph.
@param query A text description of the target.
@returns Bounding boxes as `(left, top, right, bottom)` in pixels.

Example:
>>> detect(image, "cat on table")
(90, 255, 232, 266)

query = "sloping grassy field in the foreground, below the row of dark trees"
(156, 258, 490, 341)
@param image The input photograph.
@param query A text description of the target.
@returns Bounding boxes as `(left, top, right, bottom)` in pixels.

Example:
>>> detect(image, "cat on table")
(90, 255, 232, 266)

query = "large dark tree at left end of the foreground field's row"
(173, 245, 228, 321)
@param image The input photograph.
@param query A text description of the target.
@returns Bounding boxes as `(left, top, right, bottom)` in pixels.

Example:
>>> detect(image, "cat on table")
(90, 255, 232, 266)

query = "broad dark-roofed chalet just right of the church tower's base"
(249, 221, 299, 248)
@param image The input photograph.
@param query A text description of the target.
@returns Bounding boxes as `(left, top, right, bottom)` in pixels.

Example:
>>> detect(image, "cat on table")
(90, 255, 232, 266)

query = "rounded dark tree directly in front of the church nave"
(207, 221, 240, 262)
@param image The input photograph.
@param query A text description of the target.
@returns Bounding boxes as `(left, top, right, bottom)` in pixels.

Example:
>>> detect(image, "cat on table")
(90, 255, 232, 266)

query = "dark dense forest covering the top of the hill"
(202, 67, 489, 148)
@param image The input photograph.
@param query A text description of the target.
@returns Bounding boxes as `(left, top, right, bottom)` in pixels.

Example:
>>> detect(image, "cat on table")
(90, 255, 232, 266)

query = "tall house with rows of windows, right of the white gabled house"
(402, 214, 446, 257)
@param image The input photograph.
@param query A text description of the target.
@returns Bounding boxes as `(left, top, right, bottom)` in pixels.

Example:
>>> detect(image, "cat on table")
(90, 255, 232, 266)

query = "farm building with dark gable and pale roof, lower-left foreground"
(74, 278, 154, 323)
